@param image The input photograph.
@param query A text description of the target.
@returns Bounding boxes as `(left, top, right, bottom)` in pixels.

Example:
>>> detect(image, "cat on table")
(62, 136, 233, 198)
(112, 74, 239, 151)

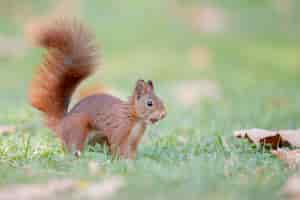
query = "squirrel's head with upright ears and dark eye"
(132, 80, 166, 124)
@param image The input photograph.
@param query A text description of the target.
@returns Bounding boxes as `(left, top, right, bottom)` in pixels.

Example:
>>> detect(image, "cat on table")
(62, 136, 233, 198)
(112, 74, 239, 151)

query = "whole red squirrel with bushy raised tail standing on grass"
(29, 19, 166, 159)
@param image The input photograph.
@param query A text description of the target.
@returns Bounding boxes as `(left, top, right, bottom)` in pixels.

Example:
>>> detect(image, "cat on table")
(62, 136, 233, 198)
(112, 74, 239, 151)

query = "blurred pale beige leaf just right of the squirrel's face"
(173, 80, 221, 107)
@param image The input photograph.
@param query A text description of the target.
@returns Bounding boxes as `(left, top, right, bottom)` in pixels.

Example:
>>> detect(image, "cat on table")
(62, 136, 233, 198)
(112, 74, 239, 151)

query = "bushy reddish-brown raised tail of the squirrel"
(28, 19, 98, 129)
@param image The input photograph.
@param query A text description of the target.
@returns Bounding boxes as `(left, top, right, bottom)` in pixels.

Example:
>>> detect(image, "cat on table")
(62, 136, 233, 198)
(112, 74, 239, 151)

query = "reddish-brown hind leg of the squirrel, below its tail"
(57, 113, 91, 157)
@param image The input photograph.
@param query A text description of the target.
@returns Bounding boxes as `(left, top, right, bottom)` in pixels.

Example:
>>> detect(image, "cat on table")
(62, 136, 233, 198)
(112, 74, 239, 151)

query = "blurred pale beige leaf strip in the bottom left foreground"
(0, 177, 124, 200)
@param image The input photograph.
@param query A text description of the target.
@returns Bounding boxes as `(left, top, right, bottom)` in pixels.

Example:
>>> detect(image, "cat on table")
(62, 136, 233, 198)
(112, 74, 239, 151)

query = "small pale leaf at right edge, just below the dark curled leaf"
(272, 149, 300, 168)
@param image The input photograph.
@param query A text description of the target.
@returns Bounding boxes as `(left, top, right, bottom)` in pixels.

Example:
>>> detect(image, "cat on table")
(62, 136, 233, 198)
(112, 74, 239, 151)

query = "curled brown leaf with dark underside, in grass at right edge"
(234, 129, 300, 149)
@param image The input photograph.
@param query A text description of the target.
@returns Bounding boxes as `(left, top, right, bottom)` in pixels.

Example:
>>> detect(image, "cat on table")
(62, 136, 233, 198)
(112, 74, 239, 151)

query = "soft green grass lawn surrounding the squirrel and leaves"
(0, 0, 300, 200)
